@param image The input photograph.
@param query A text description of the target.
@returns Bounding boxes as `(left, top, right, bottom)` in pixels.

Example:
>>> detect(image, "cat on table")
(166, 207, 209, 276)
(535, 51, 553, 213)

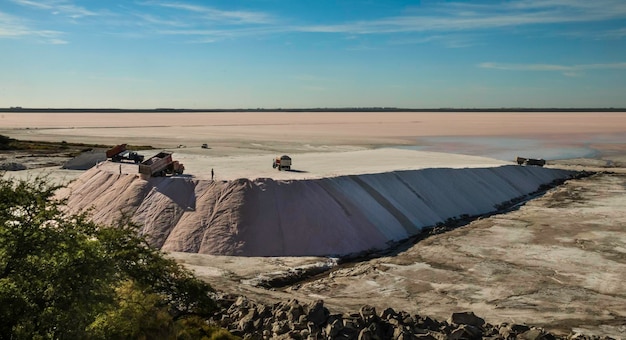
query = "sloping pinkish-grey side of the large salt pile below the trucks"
(68, 165, 572, 256)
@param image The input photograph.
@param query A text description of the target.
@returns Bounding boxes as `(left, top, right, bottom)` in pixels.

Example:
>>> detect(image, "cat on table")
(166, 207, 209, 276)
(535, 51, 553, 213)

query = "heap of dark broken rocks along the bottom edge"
(210, 294, 612, 340)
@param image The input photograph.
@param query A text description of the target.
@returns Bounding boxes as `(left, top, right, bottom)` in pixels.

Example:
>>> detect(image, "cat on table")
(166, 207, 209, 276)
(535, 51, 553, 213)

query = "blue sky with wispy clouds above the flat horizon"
(0, 0, 626, 108)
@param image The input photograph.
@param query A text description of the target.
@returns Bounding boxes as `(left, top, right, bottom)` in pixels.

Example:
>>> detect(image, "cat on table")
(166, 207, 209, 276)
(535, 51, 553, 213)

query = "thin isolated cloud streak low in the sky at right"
(478, 62, 626, 76)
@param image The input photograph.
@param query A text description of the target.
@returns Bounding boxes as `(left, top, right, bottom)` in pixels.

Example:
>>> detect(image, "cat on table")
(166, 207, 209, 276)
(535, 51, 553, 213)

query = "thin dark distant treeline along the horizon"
(0, 106, 626, 113)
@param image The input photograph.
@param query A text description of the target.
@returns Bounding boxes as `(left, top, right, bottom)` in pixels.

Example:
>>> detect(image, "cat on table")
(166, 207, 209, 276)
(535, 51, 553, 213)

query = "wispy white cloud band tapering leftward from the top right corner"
(299, 0, 626, 34)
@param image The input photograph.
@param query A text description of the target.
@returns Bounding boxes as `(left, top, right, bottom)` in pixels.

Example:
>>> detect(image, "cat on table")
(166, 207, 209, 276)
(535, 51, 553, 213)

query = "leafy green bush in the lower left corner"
(0, 176, 229, 339)
